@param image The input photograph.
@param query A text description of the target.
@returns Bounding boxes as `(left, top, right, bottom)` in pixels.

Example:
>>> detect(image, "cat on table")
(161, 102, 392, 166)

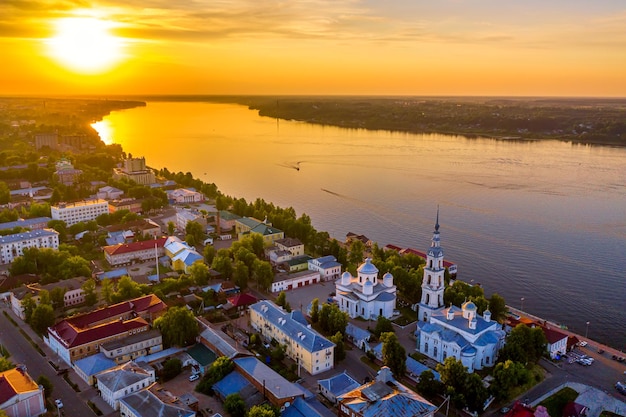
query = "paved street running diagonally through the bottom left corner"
(0, 304, 112, 417)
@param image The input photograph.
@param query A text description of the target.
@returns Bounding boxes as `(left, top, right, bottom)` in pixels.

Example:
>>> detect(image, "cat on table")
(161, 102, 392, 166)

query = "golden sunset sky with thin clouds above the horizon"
(0, 0, 626, 97)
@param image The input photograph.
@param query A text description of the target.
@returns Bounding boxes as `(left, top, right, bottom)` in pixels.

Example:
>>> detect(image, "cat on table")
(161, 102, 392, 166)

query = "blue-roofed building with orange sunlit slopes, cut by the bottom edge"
(337, 366, 437, 417)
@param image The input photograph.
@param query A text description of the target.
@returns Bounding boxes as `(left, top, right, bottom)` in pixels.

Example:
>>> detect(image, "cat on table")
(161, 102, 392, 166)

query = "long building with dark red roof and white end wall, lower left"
(43, 294, 167, 365)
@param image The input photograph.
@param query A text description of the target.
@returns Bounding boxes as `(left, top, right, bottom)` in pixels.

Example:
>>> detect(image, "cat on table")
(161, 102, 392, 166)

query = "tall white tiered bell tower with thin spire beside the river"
(417, 207, 446, 321)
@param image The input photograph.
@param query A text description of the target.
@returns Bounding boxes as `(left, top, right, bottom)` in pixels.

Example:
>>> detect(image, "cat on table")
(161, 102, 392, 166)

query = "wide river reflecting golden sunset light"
(94, 102, 626, 350)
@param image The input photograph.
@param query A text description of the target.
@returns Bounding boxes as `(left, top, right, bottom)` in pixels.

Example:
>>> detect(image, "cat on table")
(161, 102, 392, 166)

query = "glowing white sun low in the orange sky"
(48, 17, 123, 73)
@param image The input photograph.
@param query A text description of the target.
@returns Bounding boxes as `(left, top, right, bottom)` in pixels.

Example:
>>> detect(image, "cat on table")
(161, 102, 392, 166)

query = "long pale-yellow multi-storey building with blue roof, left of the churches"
(250, 300, 335, 375)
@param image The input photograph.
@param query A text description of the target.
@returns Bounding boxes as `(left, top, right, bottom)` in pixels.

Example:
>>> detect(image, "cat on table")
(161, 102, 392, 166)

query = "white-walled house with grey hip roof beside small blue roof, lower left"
(96, 362, 156, 410)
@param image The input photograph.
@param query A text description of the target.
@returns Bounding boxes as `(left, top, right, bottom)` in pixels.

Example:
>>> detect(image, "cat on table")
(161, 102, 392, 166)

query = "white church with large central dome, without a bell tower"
(335, 258, 396, 320)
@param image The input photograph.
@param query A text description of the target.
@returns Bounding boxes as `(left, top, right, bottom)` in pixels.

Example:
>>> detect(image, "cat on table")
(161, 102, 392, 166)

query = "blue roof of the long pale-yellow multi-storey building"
(250, 300, 335, 352)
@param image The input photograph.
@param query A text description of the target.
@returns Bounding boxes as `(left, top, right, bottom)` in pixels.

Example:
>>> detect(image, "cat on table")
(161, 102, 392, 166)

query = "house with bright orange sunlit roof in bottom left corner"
(0, 365, 46, 417)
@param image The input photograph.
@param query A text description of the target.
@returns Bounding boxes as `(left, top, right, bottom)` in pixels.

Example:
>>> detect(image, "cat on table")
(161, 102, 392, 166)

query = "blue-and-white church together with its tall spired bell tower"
(415, 210, 505, 372)
